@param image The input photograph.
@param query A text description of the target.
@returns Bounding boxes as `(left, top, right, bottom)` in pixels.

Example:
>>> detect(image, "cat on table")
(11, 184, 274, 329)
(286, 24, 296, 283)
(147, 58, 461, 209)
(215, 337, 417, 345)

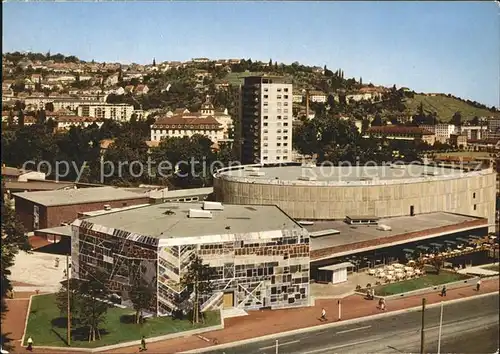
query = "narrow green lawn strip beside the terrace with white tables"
(375, 271, 470, 296)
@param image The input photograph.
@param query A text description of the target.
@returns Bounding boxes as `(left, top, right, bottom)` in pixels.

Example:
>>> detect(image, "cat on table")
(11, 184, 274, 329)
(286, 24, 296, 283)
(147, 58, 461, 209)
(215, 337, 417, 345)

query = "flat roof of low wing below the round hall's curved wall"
(304, 212, 483, 251)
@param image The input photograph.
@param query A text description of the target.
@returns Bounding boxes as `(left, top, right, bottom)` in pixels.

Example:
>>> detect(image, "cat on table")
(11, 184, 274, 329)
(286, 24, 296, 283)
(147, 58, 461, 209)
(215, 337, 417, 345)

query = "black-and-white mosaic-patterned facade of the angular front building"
(72, 220, 310, 315)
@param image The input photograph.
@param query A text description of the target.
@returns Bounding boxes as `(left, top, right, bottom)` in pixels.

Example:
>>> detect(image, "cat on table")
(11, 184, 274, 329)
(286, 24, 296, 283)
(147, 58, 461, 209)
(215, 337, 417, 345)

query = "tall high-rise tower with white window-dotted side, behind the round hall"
(240, 76, 293, 164)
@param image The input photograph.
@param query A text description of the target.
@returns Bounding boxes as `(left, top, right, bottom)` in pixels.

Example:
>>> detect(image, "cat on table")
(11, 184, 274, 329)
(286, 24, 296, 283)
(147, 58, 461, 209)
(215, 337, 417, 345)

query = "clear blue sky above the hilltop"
(2, 1, 500, 106)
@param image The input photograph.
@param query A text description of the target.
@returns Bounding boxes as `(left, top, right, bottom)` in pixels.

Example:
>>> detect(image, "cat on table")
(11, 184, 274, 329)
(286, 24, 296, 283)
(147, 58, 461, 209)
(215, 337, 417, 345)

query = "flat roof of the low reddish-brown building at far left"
(13, 187, 148, 206)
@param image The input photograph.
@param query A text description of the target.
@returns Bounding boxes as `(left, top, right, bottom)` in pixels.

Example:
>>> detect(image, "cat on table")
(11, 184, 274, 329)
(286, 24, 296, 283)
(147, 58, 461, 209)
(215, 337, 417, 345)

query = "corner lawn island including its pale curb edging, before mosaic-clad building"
(23, 294, 223, 351)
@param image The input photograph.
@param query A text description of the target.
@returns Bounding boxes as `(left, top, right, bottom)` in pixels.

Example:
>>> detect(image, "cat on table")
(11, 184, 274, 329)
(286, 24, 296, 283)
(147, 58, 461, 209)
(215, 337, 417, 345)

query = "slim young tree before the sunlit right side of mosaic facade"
(181, 254, 215, 324)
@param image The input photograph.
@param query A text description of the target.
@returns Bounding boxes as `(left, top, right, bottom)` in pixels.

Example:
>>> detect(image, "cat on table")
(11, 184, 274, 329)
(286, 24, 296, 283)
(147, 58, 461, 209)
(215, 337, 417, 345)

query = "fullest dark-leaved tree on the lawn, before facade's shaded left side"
(78, 268, 109, 342)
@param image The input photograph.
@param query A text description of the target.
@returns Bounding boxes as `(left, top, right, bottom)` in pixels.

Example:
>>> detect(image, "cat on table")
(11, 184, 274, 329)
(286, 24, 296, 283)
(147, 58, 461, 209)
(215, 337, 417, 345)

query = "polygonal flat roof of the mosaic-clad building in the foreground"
(79, 203, 302, 239)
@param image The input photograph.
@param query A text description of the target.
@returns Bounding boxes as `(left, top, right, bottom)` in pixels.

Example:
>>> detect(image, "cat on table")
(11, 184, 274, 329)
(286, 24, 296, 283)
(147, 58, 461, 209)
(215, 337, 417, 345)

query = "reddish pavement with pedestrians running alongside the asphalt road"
(104, 279, 499, 353)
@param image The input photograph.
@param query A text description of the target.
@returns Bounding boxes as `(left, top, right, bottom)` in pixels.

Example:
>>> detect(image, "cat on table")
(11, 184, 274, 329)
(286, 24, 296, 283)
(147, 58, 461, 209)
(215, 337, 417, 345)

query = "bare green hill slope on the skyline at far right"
(405, 94, 500, 122)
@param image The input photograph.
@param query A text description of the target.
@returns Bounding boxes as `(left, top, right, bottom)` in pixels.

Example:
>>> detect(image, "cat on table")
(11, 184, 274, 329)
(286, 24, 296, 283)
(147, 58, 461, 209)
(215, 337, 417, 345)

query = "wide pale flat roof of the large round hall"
(216, 164, 492, 185)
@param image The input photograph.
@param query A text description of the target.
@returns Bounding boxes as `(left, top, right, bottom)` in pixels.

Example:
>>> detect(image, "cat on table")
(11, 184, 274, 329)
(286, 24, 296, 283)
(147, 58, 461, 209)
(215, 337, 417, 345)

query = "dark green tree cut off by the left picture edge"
(0, 181, 31, 349)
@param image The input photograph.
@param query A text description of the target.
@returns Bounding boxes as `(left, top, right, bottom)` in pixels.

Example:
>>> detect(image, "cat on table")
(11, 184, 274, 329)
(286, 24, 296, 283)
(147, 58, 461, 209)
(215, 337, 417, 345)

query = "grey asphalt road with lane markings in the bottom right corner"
(200, 293, 499, 354)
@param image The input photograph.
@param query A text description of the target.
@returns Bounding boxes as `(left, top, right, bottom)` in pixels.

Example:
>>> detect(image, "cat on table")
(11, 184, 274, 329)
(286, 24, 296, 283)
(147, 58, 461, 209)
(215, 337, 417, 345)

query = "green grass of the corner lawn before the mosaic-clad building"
(25, 294, 220, 348)
